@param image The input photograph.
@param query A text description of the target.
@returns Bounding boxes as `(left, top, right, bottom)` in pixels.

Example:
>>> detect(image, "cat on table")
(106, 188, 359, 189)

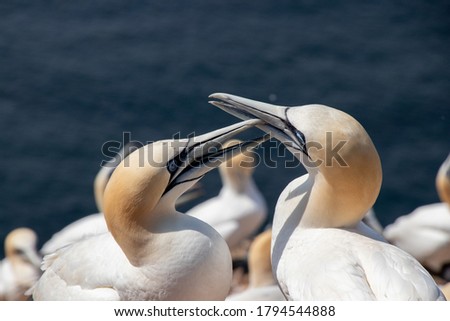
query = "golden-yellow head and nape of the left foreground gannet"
(104, 141, 175, 264)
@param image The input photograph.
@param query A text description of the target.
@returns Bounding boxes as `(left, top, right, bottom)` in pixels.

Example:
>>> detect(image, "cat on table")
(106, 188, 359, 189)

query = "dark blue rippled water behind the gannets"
(0, 0, 450, 255)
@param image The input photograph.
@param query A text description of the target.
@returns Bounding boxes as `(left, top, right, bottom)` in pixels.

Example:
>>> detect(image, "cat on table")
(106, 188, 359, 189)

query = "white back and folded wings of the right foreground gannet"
(274, 219, 443, 301)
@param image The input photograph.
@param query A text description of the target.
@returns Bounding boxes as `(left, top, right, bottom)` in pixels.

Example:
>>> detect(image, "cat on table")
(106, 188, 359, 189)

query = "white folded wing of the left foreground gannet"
(32, 233, 141, 300)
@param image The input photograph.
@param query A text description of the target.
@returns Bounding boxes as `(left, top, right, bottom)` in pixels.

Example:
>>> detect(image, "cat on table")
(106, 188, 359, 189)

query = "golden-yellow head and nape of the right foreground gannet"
(288, 105, 383, 227)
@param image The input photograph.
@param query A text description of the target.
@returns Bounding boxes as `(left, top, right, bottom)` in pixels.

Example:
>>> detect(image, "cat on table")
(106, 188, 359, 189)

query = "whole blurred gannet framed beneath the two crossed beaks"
(186, 140, 267, 251)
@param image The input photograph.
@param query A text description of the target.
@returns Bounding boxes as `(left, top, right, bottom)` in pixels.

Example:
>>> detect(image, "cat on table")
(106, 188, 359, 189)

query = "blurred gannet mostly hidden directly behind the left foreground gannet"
(40, 142, 200, 255)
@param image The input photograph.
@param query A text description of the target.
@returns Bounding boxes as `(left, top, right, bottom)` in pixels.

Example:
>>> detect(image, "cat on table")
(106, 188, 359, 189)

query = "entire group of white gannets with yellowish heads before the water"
(0, 94, 450, 301)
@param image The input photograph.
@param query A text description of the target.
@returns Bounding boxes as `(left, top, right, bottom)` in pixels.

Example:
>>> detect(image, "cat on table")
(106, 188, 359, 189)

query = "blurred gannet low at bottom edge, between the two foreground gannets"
(226, 229, 286, 301)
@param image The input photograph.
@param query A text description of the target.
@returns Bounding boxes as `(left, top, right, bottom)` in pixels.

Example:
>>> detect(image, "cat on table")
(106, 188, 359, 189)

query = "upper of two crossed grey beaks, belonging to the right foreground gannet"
(209, 93, 308, 155)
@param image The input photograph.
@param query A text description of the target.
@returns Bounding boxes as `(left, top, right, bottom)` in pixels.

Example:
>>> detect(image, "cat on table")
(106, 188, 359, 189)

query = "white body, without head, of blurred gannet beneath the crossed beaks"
(186, 178, 267, 249)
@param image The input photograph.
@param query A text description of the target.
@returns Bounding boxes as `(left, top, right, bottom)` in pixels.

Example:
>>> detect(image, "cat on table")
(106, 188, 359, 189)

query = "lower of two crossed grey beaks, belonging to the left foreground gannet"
(164, 119, 270, 194)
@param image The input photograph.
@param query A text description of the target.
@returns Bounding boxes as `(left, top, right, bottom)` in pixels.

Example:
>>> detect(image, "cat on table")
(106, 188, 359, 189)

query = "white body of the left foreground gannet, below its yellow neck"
(33, 219, 231, 301)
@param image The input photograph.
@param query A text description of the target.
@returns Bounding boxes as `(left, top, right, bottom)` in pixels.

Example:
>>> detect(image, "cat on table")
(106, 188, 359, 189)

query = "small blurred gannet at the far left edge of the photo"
(0, 227, 41, 301)
